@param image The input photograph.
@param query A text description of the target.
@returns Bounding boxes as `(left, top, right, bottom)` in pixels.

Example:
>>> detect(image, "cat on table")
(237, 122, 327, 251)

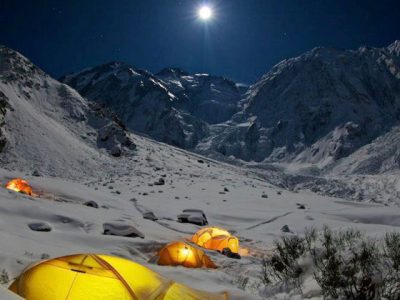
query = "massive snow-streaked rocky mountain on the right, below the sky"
(198, 41, 400, 171)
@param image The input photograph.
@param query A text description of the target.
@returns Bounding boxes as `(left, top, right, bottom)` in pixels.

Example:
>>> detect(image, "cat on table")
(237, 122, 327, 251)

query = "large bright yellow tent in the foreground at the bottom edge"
(10, 254, 228, 300)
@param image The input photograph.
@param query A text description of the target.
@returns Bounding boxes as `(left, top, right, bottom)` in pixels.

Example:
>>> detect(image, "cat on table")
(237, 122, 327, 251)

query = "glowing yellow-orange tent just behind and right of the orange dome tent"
(192, 227, 239, 253)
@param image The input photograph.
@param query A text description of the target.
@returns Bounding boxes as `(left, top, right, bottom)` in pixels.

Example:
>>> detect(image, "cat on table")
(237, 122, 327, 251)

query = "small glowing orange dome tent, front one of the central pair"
(157, 242, 217, 268)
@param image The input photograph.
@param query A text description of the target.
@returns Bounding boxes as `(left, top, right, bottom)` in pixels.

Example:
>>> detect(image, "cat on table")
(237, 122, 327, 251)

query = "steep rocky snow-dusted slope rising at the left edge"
(0, 46, 136, 176)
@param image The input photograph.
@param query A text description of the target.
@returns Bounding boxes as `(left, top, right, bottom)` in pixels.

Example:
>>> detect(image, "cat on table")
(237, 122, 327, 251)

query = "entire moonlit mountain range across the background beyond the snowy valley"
(62, 41, 400, 175)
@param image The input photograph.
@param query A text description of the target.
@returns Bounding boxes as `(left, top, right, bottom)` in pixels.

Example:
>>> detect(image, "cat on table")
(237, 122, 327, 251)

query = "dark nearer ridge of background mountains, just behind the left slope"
(61, 62, 206, 148)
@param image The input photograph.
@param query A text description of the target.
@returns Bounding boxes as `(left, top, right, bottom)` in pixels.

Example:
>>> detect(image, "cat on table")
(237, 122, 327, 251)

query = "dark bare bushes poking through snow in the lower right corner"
(261, 227, 400, 300)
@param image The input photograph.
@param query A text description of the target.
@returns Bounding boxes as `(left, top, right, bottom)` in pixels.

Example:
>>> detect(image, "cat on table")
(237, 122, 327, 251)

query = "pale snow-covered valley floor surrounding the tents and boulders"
(0, 137, 400, 299)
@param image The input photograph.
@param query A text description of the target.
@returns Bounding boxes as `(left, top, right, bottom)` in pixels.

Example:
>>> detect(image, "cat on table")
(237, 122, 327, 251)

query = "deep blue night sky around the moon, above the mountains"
(0, 0, 400, 83)
